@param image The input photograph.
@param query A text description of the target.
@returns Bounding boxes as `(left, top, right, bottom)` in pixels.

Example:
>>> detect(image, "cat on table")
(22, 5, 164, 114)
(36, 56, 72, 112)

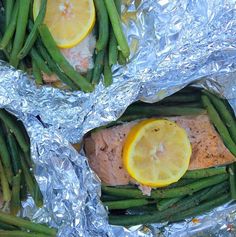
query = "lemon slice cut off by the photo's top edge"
(33, 0, 95, 48)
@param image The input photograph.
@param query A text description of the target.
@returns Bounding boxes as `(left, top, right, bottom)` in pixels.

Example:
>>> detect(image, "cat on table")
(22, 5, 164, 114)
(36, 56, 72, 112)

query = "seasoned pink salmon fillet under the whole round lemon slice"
(84, 115, 235, 185)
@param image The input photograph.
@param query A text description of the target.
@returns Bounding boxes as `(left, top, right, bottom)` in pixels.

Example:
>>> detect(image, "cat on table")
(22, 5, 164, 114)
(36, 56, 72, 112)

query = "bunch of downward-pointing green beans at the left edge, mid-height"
(0, 109, 43, 215)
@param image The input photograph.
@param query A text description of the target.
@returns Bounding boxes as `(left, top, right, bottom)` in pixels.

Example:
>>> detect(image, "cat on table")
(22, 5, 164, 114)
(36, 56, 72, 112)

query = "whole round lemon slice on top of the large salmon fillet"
(123, 119, 192, 187)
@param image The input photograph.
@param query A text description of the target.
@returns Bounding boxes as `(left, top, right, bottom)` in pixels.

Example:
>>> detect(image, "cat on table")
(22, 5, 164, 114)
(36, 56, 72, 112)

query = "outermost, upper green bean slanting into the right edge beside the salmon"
(204, 91, 236, 144)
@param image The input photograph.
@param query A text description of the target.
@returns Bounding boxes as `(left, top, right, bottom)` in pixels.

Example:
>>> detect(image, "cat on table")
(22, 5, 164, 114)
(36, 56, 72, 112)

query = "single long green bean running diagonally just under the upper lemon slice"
(39, 24, 93, 92)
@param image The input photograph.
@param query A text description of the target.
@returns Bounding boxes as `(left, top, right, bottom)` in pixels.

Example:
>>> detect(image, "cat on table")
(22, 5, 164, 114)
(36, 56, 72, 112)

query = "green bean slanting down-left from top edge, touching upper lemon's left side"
(17, 0, 47, 59)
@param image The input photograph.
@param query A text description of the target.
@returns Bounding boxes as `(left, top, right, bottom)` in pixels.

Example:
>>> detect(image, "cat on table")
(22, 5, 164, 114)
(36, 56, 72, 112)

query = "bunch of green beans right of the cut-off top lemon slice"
(91, 0, 130, 87)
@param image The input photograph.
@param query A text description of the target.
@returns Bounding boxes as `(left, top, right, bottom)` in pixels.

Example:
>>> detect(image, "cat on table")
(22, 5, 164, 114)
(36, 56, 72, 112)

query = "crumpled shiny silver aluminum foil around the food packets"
(0, 0, 236, 236)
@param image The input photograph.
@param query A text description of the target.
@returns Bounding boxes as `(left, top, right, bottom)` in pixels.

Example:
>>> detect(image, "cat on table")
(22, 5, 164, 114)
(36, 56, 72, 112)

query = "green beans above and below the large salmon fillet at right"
(101, 87, 236, 226)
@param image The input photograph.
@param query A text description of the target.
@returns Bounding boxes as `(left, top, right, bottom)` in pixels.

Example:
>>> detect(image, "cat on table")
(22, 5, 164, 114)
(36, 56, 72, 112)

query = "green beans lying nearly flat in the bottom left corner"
(0, 211, 57, 237)
